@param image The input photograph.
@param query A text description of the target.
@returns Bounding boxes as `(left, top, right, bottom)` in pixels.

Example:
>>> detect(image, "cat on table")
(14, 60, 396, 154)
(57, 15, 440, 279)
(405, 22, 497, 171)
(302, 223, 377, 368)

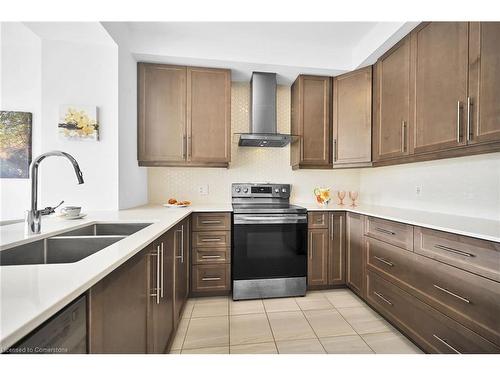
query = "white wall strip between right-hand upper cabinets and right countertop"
(360, 153, 500, 220)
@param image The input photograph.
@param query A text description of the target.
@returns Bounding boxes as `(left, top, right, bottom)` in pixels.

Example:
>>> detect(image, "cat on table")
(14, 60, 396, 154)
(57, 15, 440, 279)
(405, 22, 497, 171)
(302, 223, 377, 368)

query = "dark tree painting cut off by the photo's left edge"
(0, 111, 32, 178)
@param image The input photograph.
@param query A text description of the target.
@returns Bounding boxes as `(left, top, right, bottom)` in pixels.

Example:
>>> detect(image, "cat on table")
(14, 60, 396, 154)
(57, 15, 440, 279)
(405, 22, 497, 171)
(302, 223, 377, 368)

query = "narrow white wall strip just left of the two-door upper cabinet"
(103, 22, 148, 209)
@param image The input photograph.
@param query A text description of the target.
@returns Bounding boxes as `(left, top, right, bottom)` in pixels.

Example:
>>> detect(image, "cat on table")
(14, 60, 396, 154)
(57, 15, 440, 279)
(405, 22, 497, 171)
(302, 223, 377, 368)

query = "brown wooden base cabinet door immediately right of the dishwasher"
(88, 247, 151, 354)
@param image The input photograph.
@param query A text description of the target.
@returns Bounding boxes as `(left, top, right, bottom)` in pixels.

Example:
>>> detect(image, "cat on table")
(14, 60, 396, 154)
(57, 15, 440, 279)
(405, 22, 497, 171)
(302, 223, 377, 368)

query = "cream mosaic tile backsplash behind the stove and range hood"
(148, 82, 359, 203)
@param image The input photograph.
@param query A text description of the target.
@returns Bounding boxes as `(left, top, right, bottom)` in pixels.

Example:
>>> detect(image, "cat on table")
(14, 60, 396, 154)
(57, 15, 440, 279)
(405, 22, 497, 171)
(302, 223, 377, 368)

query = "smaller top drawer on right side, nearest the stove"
(365, 217, 413, 251)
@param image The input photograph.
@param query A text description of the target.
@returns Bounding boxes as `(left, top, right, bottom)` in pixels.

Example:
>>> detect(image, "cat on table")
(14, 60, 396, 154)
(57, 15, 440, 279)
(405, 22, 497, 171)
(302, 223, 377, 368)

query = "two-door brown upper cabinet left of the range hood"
(137, 63, 231, 167)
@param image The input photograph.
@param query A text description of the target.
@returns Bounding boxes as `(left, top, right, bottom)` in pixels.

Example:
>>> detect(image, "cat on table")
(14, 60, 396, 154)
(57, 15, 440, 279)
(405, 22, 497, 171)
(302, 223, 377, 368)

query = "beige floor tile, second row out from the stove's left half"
(229, 314, 274, 345)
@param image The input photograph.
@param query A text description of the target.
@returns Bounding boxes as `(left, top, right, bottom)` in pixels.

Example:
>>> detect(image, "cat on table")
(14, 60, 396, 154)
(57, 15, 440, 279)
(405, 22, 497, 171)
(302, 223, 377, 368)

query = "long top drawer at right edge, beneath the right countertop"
(415, 227, 500, 282)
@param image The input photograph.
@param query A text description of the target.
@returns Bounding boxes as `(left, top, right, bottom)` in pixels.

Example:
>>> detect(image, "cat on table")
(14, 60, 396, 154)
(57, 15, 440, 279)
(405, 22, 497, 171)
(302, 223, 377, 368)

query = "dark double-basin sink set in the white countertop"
(0, 223, 151, 266)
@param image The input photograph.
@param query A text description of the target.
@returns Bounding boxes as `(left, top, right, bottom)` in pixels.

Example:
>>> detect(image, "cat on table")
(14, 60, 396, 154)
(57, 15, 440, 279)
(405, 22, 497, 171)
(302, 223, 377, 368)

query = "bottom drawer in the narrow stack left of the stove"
(192, 264, 231, 293)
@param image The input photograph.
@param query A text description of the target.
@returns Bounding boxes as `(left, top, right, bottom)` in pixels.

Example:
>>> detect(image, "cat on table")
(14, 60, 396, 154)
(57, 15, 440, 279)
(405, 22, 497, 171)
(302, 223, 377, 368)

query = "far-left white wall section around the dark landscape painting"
(0, 22, 42, 221)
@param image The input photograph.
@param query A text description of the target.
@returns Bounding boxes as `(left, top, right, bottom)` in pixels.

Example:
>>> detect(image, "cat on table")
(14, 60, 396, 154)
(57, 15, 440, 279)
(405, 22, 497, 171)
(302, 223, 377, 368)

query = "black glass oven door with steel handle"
(232, 214, 307, 280)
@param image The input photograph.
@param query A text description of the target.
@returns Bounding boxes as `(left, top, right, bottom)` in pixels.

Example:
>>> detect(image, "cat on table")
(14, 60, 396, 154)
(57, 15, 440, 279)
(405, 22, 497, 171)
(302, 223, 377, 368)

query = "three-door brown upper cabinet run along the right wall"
(373, 22, 500, 166)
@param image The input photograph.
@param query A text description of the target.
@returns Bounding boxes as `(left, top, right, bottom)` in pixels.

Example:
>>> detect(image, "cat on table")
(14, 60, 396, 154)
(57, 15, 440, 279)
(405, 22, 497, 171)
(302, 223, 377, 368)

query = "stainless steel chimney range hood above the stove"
(238, 72, 292, 147)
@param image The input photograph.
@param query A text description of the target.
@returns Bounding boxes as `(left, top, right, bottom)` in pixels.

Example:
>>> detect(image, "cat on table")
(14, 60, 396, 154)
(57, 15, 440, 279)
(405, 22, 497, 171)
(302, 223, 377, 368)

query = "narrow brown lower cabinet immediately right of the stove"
(307, 212, 345, 288)
